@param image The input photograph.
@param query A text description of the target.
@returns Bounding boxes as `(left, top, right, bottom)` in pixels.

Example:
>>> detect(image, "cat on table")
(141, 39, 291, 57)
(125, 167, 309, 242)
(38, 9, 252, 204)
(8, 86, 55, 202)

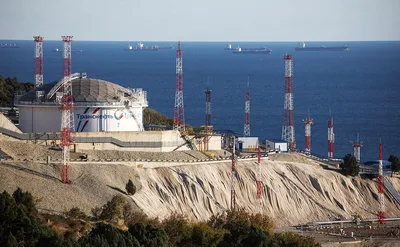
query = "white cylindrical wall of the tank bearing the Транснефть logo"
(19, 106, 143, 133)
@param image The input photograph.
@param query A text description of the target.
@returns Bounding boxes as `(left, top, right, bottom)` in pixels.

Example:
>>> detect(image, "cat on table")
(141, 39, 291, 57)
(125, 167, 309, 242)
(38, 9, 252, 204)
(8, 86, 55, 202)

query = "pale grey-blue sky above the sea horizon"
(0, 0, 400, 41)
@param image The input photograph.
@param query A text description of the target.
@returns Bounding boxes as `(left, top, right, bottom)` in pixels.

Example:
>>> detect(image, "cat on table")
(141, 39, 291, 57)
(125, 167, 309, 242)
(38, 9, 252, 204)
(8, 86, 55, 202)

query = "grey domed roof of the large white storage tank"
(19, 77, 126, 102)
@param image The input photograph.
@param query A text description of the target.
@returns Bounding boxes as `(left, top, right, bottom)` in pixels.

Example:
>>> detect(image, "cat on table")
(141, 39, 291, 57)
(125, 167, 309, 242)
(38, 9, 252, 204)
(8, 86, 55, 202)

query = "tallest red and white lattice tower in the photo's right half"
(282, 54, 296, 151)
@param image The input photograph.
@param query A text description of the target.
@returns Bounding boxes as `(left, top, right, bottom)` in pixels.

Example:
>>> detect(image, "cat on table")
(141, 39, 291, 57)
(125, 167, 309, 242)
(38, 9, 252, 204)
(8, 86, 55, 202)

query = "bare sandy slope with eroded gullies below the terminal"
(0, 145, 400, 226)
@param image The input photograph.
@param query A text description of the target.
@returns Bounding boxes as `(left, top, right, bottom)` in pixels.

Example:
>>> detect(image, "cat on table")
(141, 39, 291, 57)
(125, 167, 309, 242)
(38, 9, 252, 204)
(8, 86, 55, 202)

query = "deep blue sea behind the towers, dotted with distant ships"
(0, 41, 400, 161)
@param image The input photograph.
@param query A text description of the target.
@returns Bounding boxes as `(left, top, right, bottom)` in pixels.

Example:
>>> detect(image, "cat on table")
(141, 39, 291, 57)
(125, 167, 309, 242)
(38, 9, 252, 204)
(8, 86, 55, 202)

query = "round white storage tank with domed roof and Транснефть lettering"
(15, 73, 148, 133)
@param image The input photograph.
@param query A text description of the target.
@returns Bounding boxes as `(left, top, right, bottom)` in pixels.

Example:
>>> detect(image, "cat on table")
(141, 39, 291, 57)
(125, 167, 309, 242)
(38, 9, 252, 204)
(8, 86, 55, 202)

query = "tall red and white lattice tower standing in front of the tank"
(61, 36, 75, 184)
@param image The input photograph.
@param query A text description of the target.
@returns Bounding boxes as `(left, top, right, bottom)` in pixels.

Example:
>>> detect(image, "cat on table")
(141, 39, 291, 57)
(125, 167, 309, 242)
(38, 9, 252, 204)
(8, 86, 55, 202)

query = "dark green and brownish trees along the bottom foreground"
(0, 189, 320, 247)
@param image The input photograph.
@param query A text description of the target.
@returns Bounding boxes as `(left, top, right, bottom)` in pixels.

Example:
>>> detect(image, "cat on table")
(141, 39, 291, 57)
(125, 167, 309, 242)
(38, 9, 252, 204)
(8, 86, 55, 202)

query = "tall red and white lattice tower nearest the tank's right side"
(174, 41, 185, 132)
